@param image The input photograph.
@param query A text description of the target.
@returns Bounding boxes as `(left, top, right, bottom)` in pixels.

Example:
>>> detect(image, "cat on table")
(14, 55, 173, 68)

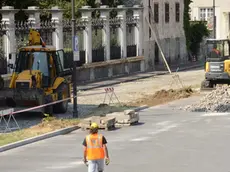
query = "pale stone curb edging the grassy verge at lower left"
(0, 126, 80, 152)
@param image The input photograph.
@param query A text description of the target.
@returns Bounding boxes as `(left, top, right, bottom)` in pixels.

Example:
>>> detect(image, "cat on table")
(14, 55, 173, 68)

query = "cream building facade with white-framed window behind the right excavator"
(190, 0, 230, 39)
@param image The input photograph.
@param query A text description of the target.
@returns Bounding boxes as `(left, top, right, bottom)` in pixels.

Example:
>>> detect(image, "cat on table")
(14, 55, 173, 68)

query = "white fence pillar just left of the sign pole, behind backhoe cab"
(51, 6, 64, 66)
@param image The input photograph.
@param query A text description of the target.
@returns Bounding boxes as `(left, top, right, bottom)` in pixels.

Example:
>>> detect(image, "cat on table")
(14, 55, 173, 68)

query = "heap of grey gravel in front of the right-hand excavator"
(184, 86, 230, 112)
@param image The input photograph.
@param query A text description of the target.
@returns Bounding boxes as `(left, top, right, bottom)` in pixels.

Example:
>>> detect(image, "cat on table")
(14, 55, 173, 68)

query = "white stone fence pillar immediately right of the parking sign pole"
(80, 6, 93, 64)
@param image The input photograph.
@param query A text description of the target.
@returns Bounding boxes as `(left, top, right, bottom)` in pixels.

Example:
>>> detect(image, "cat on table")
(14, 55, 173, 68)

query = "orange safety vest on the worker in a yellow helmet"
(86, 134, 105, 160)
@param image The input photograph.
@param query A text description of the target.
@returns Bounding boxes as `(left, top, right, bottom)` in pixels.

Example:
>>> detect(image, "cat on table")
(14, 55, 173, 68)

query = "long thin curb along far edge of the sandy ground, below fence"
(78, 65, 203, 91)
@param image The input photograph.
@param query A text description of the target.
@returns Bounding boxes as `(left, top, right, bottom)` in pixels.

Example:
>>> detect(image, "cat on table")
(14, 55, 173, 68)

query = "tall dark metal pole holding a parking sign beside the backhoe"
(71, 0, 78, 118)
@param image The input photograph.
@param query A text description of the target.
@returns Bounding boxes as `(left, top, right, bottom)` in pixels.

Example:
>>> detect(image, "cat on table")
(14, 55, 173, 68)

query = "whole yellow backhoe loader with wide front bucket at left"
(0, 29, 72, 114)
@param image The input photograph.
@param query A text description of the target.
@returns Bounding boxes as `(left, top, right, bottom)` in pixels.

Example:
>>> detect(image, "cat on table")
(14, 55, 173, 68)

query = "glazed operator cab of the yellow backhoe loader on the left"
(12, 46, 63, 88)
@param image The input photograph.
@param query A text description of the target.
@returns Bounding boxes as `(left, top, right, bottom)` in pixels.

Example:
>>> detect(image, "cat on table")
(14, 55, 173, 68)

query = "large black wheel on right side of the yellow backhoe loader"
(53, 83, 69, 113)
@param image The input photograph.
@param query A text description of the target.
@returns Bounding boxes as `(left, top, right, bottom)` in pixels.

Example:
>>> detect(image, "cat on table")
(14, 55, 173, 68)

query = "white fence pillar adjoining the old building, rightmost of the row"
(133, 5, 144, 56)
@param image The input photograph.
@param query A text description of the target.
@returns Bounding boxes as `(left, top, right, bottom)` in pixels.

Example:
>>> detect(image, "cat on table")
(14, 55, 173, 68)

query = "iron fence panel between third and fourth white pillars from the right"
(92, 18, 105, 62)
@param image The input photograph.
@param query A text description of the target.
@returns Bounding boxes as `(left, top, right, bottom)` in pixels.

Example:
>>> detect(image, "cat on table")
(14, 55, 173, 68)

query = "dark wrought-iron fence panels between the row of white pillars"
(0, 12, 136, 74)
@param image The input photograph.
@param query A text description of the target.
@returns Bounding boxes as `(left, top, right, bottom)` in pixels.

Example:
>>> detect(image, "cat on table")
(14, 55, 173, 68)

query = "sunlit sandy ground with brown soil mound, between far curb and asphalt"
(78, 69, 204, 110)
